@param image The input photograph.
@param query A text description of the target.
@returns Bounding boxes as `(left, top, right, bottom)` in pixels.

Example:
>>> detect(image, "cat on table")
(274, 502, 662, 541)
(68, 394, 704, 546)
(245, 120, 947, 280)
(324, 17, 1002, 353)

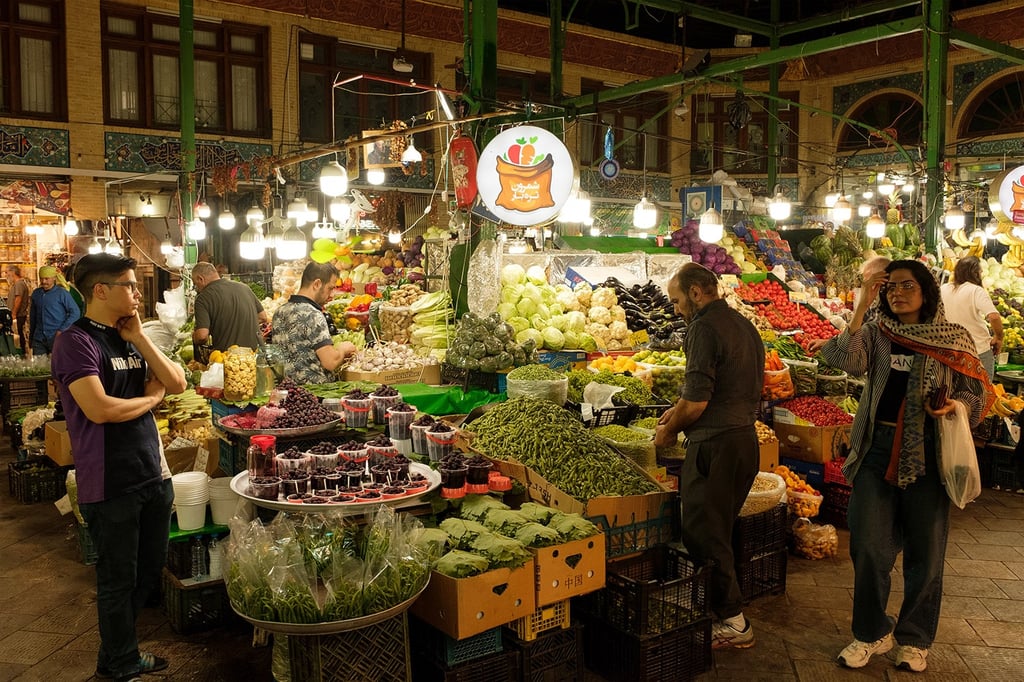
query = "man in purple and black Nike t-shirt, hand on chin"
(50, 254, 185, 682)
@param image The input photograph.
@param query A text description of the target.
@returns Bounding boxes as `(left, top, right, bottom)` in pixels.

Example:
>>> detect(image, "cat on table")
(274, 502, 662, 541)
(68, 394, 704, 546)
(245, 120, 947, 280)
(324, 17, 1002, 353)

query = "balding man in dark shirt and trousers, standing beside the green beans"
(654, 263, 765, 648)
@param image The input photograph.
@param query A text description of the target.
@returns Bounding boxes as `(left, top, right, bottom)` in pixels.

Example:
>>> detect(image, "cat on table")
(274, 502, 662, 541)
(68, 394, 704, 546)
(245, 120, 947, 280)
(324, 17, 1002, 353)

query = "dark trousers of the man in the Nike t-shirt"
(80, 479, 174, 677)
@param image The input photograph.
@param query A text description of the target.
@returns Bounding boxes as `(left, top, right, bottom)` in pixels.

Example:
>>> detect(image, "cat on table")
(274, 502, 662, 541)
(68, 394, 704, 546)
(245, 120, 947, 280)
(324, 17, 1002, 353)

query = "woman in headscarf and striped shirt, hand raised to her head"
(821, 260, 993, 672)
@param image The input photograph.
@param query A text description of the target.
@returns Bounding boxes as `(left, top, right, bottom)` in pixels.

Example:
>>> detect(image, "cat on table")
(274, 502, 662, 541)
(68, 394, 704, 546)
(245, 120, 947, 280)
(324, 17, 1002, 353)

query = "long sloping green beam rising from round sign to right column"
(562, 16, 923, 113)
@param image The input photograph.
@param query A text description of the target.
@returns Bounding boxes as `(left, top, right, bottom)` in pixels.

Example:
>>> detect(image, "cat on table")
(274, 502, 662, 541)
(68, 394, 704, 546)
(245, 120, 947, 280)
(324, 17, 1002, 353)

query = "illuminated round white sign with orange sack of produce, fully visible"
(476, 126, 575, 225)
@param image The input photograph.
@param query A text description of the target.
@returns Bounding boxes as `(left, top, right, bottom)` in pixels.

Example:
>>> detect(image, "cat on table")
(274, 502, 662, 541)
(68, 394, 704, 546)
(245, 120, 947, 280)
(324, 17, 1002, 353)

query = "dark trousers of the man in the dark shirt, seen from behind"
(679, 426, 759, 619)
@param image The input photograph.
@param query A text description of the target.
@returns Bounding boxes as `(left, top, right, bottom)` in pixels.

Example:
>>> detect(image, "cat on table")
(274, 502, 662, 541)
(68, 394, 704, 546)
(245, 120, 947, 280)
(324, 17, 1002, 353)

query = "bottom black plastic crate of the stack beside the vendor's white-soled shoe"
(584, 617, 712, 682)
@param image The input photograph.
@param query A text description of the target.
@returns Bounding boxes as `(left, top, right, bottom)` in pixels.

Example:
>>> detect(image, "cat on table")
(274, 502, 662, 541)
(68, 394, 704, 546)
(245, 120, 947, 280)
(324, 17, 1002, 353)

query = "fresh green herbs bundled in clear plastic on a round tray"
(226, 507, 446, 624)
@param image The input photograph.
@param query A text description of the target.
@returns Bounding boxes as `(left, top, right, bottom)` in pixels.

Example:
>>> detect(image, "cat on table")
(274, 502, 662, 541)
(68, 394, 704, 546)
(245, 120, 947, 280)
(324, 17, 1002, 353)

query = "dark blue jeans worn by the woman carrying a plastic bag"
(847, 420, 949, 649)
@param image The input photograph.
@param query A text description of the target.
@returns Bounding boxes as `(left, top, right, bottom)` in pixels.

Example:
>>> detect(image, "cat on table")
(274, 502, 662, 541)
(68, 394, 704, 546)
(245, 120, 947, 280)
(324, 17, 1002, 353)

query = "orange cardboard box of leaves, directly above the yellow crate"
(530, 534, 607, 606)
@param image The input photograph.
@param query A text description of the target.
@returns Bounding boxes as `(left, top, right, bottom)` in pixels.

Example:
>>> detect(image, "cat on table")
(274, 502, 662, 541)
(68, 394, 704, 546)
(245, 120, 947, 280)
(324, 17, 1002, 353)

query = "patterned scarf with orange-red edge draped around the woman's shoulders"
(878, 303, 995, 488)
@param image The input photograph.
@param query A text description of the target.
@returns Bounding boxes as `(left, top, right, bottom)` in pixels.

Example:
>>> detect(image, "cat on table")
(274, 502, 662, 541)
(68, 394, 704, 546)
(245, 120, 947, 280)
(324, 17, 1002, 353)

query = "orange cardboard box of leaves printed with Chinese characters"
(410, 561, 536, 639)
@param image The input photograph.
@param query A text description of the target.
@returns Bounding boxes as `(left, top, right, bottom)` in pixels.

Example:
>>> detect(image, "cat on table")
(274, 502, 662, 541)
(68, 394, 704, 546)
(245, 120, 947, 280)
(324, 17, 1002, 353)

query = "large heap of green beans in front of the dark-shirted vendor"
(468, 396, 658, 502)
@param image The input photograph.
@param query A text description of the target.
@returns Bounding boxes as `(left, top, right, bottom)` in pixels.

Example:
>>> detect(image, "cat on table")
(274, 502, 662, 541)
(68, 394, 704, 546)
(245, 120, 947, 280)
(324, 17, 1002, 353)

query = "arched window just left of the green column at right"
(837, 92, 925, 153)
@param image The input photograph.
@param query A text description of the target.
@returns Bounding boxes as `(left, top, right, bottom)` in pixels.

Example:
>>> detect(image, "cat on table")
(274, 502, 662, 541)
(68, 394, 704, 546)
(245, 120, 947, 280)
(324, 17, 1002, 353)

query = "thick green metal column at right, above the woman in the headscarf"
(922, 0, 949, 256)
